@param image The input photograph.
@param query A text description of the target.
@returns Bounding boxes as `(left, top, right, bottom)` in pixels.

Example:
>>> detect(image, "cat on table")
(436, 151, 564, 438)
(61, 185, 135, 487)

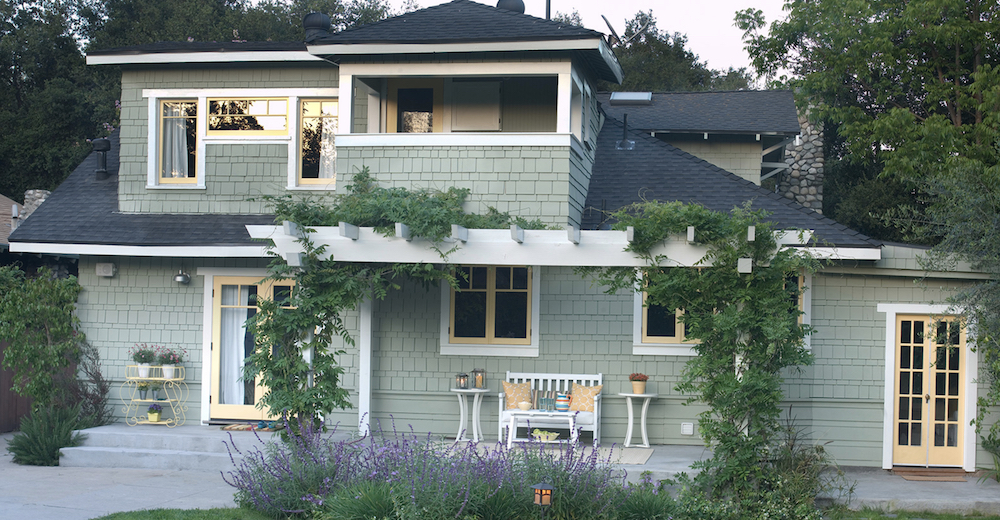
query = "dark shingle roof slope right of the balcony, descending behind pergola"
(583, 115, 879, 248)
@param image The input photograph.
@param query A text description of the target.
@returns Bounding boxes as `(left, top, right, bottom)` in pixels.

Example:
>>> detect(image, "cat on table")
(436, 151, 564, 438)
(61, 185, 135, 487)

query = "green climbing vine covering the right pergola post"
(581, 202, 816, 504)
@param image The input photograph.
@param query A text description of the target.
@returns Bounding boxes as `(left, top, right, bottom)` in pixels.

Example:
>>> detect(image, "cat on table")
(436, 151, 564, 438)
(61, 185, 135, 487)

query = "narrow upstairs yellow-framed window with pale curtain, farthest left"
(157, 99, 198, 184)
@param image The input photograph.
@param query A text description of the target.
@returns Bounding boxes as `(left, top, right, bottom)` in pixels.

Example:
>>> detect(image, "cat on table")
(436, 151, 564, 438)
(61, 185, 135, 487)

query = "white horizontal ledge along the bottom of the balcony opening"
(336, 132, 572, 148)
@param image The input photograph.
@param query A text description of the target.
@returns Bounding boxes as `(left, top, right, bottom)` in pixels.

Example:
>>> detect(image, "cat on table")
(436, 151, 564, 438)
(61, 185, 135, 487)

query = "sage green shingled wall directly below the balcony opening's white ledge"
(337, 146, 579, 226)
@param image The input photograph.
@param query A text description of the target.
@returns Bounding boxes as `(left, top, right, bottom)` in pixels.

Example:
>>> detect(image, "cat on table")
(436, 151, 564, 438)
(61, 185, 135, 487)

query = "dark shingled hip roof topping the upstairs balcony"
(310, 0, 603, 45)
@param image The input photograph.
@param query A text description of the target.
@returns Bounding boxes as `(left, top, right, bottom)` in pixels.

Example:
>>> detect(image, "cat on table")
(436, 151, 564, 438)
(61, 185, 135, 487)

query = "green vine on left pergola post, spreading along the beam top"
(243, 168, 544, 424)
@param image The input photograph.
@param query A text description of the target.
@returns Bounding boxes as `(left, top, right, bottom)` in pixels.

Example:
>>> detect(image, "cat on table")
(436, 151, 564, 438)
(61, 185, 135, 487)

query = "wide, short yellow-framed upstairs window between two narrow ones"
(208, 98, 288, 135)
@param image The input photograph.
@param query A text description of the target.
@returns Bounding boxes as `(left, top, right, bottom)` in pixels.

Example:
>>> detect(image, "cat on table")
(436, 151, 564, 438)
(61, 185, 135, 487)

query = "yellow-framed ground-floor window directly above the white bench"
(448, 266, 531, 345)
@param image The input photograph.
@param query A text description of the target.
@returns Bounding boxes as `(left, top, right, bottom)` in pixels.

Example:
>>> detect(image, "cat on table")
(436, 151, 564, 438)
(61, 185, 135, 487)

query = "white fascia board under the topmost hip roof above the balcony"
(308, 38, 606, 55)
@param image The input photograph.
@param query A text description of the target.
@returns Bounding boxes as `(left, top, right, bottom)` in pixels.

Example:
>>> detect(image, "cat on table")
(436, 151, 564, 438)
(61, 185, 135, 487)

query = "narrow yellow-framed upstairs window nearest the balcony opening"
(299, 99, 338, 184)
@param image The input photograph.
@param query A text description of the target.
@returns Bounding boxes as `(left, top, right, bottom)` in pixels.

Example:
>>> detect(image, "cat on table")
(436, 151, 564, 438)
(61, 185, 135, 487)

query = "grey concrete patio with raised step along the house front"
(0, 425, 1000, 520)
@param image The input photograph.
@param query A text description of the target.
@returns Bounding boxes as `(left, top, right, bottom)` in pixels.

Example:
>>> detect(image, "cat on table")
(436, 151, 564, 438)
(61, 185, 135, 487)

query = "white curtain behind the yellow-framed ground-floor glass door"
(219, 285, 250, 404)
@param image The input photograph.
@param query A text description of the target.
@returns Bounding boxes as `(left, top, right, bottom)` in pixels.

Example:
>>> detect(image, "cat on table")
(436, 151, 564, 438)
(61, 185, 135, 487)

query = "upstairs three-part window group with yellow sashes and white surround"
(142, 88, 339, 190)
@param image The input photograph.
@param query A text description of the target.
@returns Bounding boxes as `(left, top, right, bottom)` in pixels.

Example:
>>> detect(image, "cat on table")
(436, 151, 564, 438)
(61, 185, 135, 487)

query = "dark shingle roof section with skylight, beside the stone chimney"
(597, 90, 800, 135)
